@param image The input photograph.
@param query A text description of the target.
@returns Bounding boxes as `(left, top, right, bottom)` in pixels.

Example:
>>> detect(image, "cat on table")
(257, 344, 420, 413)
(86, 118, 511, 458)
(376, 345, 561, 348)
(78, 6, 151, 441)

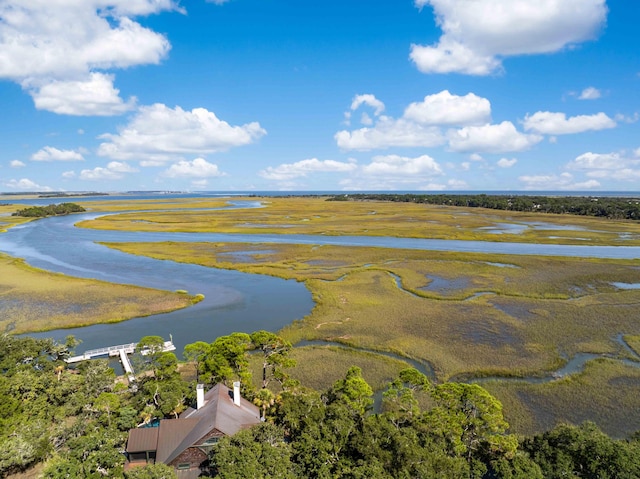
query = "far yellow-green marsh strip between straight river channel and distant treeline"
(81, 197, 640, 245)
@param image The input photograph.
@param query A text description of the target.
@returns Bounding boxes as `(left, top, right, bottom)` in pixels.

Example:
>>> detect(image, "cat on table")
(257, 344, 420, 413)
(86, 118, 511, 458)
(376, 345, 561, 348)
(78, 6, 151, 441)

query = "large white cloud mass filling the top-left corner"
(0, 0, 175, 115)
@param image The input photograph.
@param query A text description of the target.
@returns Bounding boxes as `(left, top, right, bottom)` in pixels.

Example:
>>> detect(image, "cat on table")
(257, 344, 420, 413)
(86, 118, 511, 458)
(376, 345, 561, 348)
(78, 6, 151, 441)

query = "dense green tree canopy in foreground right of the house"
(212, 368, 640, 479)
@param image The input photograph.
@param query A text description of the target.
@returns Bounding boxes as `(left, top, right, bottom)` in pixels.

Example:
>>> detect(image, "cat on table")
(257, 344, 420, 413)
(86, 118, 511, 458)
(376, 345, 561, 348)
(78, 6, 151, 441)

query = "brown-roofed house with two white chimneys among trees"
(125, 382, 260, 479)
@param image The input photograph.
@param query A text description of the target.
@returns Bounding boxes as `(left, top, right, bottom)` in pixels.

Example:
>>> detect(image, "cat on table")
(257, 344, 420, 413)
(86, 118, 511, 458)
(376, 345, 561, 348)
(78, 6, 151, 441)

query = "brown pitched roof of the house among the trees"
(127, 384, 260, 464)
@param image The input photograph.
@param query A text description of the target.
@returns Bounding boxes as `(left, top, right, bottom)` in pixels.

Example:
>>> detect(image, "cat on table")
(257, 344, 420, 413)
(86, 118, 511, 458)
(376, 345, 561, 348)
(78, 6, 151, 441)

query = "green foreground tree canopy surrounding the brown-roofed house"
(0, 331, 640, 479)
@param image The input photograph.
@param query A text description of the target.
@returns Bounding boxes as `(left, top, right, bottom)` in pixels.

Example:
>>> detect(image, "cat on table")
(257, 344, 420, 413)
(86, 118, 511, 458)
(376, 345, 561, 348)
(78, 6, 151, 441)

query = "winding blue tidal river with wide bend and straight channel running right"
(0, 201, 640, 353)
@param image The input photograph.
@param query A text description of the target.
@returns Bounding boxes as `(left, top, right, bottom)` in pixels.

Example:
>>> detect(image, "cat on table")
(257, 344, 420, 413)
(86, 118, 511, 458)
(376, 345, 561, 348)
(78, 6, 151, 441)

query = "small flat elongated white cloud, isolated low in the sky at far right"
(524, 111, 616, 135)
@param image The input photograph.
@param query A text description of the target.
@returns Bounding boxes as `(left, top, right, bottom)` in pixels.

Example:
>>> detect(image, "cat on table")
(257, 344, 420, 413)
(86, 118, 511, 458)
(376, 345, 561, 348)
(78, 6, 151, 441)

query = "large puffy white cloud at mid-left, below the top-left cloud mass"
(98, 103, 266, 161)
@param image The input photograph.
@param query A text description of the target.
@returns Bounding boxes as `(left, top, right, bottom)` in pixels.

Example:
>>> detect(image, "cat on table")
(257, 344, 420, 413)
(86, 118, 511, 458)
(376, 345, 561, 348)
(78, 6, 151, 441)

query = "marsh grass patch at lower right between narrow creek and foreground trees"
(482, 359, 640, 437)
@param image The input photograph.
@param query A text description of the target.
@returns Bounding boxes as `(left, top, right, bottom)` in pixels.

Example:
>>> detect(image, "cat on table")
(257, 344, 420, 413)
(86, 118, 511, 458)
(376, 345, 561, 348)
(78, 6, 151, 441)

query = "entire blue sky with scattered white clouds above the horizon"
(0, 0, 640, 192)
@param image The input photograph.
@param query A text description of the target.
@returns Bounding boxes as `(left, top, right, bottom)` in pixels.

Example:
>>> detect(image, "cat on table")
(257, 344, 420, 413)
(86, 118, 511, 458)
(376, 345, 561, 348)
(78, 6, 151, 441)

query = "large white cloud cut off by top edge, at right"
(410, 0, 607, 75)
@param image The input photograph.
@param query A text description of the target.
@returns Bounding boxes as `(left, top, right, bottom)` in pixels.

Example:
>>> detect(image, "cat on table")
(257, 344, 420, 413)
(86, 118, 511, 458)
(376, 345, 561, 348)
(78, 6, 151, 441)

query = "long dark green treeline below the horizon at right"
(329, 193, 640, 220)
